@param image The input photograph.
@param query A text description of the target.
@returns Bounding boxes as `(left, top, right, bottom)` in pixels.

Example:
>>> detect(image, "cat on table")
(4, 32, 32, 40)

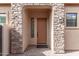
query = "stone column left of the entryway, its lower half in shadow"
(10, 3, 23, 53)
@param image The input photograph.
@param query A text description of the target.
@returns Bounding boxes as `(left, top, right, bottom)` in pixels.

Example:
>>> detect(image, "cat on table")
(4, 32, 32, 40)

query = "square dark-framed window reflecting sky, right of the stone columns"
(66, 13, 77, 27)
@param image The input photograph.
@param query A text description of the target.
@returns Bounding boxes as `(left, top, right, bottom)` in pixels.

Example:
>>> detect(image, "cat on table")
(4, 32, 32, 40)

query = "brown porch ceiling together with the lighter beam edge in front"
(24, 5, 52, 17)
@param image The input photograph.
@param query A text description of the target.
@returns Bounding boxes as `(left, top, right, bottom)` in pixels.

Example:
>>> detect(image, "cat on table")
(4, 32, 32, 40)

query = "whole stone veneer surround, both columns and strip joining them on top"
(10, 3, 64, 53)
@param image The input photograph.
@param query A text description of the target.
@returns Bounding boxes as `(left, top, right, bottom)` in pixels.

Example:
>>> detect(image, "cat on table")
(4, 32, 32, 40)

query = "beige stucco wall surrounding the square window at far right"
(65, 6, 79, 50)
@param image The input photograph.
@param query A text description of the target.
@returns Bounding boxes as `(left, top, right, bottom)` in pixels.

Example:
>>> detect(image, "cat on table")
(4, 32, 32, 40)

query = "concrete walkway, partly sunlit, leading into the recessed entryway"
(9, 46, 79, 56)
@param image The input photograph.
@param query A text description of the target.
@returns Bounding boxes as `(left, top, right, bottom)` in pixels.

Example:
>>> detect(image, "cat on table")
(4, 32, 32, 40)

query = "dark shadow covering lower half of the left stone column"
(10, 28, 22, 53)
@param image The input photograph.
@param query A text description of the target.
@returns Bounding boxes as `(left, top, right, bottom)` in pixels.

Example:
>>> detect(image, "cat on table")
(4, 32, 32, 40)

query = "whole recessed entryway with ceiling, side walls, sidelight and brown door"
(23, 6, 52, 51)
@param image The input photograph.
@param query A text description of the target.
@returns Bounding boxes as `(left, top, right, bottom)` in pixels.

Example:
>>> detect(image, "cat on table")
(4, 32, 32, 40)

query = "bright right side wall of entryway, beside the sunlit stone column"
(48, 7, 54, 52)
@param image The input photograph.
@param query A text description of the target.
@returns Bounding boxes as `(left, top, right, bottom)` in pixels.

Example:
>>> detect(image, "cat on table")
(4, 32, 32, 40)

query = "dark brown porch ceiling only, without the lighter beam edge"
(27, 8, 51, 17)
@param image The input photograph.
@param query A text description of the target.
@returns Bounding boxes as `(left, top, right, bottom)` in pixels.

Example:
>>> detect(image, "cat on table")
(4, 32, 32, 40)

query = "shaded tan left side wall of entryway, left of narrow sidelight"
(23, 8, 30, 51)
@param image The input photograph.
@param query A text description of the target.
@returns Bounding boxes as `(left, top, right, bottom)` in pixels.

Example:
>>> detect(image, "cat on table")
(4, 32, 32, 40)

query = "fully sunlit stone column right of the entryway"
(53, 3, 64, 53)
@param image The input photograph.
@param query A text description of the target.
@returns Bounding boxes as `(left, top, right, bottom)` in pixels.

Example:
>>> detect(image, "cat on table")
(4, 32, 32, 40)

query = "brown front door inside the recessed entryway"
(37, 18, 47, 44)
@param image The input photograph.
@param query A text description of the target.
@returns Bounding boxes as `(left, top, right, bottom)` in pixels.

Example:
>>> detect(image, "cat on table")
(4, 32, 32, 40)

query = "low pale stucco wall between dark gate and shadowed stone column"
(2, 25, 10, 55)
